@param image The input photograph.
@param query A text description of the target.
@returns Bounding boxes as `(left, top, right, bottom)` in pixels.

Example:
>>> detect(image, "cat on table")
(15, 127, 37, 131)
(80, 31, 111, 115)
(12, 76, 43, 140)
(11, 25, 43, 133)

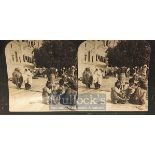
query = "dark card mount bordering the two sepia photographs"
(0, 40, 155, 115)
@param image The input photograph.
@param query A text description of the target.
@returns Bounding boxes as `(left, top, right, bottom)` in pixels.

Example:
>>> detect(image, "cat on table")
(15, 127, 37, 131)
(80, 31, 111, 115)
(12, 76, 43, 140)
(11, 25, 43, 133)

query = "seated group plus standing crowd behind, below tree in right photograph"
(111, 65, 149, 105)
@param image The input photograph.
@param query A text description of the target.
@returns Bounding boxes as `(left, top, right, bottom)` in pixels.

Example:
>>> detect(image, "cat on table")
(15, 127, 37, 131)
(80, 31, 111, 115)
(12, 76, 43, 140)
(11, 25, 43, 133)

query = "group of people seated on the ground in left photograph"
(42, 76, 77, 105)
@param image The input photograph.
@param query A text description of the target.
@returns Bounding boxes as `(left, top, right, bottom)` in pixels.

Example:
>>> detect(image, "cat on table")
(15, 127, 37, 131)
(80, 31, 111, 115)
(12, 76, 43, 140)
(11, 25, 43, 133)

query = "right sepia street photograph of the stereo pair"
(78, 40, 151, 111)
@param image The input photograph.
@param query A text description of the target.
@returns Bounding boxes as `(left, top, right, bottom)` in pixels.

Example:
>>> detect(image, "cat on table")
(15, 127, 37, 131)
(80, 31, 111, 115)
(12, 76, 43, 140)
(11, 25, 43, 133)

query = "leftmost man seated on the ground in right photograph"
(111, 81, 126, 104)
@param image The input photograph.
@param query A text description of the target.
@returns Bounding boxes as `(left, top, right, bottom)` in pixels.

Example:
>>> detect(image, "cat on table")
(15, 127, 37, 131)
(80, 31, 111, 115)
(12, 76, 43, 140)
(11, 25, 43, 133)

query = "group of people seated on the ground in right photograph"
(111, 74, 147, 105)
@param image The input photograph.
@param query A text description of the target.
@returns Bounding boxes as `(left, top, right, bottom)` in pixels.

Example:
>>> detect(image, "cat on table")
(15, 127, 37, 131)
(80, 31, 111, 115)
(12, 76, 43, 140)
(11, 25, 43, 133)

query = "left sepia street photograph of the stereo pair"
(5, 40, 81, 112)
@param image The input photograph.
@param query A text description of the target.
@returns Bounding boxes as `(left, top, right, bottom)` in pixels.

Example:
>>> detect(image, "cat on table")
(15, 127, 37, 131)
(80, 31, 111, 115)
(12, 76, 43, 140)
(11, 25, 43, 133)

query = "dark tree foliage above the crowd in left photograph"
(34, 40, 82, 68)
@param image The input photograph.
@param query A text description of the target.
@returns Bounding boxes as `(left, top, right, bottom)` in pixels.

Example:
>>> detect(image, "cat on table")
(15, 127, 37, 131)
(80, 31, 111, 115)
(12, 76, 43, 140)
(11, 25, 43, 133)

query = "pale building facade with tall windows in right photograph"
(78, 40, 118, 78)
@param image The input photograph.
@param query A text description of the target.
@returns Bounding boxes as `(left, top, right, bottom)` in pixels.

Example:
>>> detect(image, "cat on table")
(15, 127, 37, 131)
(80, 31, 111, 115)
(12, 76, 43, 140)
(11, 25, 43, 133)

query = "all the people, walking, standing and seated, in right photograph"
(82, 65, 149, 105)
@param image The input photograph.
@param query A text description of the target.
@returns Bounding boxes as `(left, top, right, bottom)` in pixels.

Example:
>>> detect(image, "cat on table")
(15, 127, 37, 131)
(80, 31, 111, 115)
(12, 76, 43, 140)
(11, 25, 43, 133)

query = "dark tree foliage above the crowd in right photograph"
(107, 40, 151, 67)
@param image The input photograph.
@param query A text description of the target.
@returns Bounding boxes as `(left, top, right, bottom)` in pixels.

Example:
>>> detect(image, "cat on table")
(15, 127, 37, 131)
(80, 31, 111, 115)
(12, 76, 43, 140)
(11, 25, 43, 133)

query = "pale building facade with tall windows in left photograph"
(5, 40, 42, 78)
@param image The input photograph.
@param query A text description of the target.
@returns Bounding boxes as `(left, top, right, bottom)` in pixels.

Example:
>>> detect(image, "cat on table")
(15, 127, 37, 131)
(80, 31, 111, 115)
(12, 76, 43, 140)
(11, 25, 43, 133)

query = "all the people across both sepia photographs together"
(12, 65, 148, 105)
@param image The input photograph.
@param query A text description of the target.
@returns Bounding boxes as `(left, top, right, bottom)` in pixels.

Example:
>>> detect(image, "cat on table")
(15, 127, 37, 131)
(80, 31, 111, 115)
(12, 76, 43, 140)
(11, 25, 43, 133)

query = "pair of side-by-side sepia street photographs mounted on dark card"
(5, 40, 151, 112)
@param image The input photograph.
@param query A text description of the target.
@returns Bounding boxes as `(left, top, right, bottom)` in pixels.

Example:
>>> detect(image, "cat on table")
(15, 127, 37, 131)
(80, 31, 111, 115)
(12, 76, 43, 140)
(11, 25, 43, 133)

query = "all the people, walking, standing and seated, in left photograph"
(12, 66, 78, 105)
